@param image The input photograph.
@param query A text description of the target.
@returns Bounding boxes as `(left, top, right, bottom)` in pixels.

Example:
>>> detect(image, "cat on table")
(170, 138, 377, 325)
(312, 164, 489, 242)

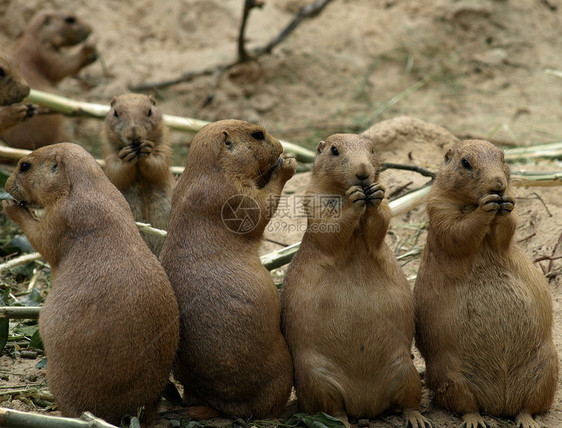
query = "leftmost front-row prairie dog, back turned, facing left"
(4, 143, 179, 424)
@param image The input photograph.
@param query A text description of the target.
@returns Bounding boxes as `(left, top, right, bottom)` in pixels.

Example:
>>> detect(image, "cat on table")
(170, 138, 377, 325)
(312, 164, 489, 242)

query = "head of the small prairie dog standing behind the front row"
(105, 94, 165, 149)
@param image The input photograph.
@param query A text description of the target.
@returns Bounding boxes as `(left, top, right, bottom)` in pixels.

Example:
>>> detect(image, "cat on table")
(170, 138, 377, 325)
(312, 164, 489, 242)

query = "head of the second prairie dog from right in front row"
(311, 134, 382, 194)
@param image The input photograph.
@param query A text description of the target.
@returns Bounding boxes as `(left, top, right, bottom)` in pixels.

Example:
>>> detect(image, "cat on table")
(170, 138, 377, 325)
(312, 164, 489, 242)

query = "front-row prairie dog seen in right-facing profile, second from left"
(160, 120, 296, 418)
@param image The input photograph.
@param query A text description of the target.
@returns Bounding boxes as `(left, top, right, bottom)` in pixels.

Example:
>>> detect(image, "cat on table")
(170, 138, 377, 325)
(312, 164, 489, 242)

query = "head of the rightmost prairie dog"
(436, 140, 510, 205)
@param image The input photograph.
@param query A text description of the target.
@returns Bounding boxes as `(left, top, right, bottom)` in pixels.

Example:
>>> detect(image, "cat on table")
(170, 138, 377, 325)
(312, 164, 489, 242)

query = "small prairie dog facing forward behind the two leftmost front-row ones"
(104, 94, 174, 256)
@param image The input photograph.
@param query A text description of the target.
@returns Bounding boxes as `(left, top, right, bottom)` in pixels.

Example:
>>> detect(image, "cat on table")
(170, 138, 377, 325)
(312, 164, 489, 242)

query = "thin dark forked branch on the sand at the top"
(129, 0, 333, 92)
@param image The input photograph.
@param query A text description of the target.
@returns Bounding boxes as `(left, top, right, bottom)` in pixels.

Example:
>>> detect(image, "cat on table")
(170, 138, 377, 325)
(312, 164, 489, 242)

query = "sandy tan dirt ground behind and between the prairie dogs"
(0, 0, 562, 428)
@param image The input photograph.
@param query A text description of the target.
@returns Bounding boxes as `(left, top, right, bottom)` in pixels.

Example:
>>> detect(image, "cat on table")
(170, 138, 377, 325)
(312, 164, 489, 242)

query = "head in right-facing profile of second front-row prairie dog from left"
(188, 120, 283, 187)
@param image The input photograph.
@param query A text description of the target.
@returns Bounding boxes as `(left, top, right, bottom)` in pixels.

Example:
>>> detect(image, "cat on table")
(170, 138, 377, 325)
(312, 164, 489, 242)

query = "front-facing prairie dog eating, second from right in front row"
(281, 134, 430, 427)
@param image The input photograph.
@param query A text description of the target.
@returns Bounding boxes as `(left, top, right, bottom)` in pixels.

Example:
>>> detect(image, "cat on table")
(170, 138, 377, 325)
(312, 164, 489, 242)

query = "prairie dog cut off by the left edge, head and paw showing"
(0, 52, 36, 133)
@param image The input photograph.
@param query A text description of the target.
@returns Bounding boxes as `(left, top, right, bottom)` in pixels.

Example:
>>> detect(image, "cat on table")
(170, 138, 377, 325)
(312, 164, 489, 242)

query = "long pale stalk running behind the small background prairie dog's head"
(25, 89, 316, 162)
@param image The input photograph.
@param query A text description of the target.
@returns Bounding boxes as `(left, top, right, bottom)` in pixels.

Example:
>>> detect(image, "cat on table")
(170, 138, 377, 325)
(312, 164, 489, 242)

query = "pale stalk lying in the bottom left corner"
(0, 407, 117, 428)
